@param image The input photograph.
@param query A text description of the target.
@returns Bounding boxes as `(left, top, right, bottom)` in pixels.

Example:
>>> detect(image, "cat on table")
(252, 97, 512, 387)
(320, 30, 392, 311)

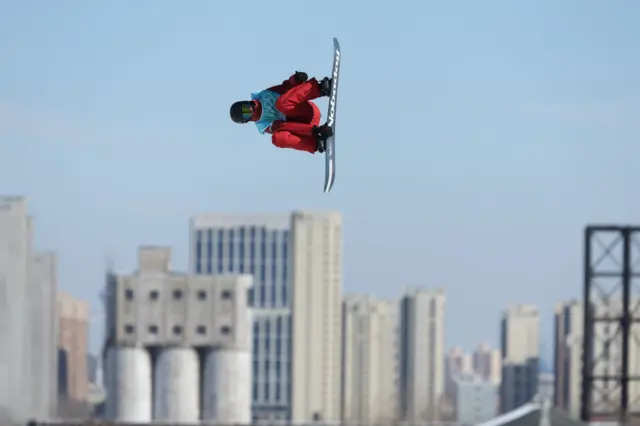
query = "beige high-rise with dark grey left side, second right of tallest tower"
(399, 288, 446, 422)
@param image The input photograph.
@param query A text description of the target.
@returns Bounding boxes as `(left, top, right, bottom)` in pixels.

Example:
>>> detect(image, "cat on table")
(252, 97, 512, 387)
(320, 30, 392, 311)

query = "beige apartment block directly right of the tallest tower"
(342, 295, 398, 424)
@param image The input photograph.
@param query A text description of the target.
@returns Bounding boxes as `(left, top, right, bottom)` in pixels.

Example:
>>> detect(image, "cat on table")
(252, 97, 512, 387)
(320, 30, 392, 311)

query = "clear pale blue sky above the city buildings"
(0, 0, 640, 358)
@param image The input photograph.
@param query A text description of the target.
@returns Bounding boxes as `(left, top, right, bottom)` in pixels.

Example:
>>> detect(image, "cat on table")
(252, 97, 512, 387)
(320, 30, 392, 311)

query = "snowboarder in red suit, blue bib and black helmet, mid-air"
(230, 71, 333, 154)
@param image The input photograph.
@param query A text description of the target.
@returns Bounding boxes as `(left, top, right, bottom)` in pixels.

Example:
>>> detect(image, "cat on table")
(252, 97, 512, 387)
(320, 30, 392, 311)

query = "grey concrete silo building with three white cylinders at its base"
(105, 247, 252, 423)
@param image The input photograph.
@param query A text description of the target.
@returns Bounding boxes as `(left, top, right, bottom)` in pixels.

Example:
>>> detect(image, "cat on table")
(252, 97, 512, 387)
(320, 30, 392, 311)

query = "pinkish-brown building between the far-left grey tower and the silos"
(57, 290, 89, 402)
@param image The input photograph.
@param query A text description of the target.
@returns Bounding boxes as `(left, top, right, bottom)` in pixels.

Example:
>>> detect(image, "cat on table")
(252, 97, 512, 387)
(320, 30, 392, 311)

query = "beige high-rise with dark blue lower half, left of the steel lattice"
(500, 304, 540, 413)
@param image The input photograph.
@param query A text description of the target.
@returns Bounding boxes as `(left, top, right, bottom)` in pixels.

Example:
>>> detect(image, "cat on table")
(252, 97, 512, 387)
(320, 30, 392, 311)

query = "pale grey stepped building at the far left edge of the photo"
(0, 196, 57, 422)
